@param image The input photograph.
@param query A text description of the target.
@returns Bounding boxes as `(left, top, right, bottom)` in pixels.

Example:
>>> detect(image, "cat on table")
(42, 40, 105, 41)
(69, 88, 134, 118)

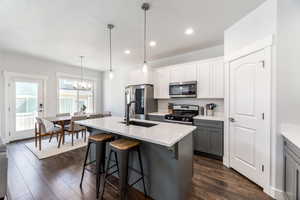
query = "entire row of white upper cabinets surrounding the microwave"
(151, 57, 225, 99)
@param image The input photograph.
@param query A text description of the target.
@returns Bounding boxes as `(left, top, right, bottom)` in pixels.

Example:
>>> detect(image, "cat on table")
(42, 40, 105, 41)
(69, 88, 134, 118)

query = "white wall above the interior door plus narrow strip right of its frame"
(224, 0, 278, 196)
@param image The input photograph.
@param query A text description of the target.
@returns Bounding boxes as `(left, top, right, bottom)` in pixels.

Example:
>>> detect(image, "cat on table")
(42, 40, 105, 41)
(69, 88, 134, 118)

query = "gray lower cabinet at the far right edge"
(284, 140, 300, 200)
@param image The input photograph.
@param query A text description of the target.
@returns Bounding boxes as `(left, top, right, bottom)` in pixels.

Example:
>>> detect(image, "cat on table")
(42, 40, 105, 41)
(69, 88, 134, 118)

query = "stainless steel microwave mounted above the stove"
(169, 81, 197, 98)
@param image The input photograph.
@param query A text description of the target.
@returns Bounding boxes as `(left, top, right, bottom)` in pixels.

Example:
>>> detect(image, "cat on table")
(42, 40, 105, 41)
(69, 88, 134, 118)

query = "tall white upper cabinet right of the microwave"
(197, 58, 225, 98)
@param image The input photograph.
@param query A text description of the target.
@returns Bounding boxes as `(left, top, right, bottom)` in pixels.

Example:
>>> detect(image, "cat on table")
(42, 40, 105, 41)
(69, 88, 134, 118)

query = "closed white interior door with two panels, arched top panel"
(230, 51, 269, 187)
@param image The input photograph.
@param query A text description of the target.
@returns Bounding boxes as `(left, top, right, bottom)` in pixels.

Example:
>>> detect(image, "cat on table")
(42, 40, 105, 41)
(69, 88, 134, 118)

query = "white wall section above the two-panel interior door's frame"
(224, 0, 277, 57)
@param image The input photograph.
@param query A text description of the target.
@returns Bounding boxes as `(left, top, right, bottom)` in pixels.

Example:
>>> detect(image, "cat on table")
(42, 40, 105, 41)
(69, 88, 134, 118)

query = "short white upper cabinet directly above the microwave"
(170, 63, 197, 83)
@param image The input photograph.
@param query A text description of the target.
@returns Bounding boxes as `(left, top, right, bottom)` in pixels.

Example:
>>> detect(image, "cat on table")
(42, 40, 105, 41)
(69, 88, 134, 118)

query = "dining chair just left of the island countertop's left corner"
(65, 115, 87, 146)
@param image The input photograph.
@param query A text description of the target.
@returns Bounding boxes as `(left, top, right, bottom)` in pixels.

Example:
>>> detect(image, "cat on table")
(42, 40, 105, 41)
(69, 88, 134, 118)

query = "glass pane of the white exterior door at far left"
(16, 82, 38, 131)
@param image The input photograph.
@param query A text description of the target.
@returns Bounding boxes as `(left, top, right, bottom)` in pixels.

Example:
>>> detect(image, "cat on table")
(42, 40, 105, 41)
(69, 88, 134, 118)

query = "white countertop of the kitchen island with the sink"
(76, 117, 196, 147)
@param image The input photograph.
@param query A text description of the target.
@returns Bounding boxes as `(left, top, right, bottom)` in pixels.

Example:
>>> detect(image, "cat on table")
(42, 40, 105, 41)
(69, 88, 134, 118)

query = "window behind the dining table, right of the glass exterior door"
(58, 79, 95, 113)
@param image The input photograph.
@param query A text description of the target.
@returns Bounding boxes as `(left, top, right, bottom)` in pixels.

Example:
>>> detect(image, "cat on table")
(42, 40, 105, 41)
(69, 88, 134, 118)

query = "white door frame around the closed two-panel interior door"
(223, 35, 275, 196)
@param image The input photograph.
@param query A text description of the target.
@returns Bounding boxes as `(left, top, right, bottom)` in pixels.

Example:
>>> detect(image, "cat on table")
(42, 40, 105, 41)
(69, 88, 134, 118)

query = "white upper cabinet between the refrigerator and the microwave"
(153, 67, 170, 99)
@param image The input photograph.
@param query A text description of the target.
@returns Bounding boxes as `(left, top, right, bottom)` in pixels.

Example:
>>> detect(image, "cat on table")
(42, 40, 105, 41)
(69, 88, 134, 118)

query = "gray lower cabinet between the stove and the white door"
(194, 120, 224, 157)
